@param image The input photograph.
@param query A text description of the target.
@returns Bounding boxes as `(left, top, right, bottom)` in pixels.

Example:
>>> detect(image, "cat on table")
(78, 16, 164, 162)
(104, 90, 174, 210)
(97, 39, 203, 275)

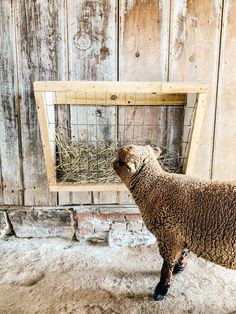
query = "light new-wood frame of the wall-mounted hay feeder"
(34, 81, 207, 192)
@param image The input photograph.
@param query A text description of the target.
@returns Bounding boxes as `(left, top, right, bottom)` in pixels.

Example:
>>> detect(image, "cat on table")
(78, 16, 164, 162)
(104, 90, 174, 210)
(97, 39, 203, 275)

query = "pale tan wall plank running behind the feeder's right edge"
(169, 0, 222, 178)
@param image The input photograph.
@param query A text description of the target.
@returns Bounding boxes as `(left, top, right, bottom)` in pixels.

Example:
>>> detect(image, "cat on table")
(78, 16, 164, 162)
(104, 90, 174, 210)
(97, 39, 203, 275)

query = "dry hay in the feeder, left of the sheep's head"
(55, 127, 121, 183)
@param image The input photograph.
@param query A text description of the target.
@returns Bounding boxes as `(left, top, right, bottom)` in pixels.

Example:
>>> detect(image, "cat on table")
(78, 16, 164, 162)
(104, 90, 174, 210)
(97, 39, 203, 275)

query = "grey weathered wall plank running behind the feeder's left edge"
(16, 0, 65, 205)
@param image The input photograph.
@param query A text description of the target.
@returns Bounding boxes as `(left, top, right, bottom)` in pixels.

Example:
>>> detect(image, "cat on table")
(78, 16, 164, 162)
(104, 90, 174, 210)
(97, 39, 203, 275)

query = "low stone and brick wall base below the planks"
(0, 205, 155, 246)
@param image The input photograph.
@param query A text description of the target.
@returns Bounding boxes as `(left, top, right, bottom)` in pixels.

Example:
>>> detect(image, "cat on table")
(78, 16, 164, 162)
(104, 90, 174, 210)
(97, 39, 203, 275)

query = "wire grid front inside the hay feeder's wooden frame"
(44, 91, 197, 183)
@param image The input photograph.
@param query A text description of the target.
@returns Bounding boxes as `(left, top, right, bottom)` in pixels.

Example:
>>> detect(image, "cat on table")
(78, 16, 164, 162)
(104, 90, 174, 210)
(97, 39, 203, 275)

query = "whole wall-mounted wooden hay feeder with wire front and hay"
(34, 81, 207, 192)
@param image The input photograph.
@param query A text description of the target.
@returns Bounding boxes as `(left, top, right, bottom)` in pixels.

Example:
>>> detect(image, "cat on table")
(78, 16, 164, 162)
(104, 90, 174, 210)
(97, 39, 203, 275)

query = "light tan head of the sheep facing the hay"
(113, 145, 161, 188)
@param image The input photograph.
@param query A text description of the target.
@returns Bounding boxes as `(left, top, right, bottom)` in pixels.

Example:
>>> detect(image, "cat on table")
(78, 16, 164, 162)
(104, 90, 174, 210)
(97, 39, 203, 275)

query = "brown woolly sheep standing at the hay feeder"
(113, 145, 236, 301)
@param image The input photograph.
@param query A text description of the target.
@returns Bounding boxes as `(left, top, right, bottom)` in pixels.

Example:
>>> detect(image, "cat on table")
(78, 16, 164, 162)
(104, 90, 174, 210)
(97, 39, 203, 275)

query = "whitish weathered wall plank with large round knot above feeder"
(66, 0, 117, 203)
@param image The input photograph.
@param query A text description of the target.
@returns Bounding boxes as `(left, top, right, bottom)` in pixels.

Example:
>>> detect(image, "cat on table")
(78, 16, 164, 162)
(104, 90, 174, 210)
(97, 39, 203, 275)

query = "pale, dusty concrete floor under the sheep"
(0, 239, 236, 314)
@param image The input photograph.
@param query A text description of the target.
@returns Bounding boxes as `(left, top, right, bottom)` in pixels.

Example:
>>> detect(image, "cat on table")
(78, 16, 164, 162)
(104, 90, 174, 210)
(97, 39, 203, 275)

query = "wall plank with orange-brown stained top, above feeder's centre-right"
(118, 0, 170, 203)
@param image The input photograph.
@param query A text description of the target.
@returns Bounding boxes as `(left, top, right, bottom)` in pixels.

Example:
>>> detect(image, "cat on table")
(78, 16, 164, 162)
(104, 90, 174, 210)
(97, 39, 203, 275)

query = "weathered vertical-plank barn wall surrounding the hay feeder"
(0, 0, 236, 206)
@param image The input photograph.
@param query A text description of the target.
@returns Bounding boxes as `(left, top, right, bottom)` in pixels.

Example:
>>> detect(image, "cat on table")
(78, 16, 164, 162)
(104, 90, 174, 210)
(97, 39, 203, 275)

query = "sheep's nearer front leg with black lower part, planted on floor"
(153, 241, 182, 301)
